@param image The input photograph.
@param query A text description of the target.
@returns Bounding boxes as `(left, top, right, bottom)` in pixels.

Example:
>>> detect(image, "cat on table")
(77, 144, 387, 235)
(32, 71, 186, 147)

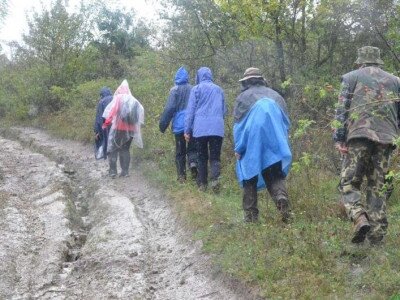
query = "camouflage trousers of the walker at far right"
(340, 139, 393, 239)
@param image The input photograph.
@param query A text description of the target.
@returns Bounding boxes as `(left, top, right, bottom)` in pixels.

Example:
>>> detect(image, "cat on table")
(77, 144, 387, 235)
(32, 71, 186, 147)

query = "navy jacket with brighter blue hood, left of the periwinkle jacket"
(159, 67, 192, 134)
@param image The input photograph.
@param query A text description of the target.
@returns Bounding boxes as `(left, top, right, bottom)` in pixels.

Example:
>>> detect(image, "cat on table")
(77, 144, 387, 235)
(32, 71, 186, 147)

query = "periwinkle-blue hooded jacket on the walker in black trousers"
(185, 67, 226, 137)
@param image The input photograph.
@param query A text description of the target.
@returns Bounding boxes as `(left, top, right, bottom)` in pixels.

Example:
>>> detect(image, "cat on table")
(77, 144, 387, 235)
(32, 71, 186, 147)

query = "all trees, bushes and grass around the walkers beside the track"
(0, 0, 400, 299)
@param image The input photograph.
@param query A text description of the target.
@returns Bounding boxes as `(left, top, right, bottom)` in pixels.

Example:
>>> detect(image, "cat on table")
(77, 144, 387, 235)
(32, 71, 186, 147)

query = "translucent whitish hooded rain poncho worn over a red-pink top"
(103, 80, 144, 153)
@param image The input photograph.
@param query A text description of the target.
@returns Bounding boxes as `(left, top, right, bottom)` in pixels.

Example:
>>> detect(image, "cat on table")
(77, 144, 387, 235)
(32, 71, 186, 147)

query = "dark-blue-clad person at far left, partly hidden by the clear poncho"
(93, 87, 112, 159)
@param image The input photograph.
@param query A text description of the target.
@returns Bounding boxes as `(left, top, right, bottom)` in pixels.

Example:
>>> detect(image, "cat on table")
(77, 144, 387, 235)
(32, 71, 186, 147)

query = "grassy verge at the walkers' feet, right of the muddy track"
(139, 145, 400, 299)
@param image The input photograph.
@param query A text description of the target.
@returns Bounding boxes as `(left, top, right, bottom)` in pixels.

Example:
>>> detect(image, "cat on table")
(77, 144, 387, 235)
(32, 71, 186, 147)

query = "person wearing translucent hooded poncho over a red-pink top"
(103, 80, 144, 178)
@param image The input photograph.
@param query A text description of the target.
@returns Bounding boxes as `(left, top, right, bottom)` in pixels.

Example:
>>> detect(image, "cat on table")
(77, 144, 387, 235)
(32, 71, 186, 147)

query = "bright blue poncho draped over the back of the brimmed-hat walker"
(233, 98, 292, 189)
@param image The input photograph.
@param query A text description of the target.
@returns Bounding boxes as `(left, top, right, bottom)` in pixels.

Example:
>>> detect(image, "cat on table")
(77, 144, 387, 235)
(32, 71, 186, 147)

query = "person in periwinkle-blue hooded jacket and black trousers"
(184, 67, 226, 193)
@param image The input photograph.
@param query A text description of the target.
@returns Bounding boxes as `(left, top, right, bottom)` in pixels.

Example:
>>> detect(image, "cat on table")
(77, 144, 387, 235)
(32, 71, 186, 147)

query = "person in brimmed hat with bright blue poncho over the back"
(233, 68, 292, 222)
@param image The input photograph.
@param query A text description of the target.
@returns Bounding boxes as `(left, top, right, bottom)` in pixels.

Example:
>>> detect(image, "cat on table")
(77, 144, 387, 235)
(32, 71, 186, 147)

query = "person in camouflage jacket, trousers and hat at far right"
(333, 46, 400, 244)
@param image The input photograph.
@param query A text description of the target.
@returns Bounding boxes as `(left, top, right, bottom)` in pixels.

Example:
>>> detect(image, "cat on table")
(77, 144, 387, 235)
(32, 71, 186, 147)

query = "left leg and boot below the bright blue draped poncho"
(242, 176, 258, 222)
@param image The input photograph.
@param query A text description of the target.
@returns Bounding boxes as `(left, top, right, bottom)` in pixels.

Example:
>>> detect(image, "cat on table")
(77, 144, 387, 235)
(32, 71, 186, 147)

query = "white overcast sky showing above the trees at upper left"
(0, 0, 156, 51)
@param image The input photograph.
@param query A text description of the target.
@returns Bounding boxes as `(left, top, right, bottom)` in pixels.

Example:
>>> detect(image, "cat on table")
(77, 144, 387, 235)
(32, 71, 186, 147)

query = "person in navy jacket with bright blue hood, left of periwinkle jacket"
(159, 67, 197, 182)
